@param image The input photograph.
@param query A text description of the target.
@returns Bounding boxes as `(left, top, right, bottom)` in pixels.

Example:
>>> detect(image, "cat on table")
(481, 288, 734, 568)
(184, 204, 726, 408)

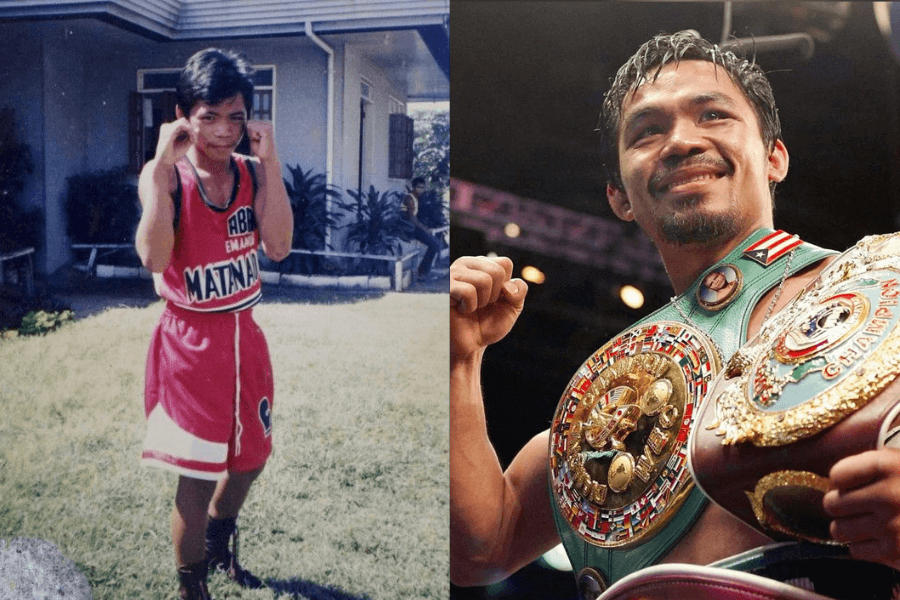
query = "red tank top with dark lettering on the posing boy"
(155, 154, 262, 312)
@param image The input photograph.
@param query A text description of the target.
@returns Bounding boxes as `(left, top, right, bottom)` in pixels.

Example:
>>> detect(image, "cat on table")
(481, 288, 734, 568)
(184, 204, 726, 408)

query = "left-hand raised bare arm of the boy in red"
(134, 118, 194, 273)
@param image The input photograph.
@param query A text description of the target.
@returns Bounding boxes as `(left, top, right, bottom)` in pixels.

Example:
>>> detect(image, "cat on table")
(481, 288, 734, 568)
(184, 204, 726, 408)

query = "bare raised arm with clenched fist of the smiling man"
(450, 257, 559, 585)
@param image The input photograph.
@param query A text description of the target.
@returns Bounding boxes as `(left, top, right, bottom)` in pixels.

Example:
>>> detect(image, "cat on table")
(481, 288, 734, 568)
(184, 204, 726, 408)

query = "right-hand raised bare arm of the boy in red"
(247, 121, 294, 262)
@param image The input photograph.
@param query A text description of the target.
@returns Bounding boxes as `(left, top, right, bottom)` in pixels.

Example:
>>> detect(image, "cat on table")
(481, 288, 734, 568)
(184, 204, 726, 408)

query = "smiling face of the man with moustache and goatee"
(607, 60, 787, 244)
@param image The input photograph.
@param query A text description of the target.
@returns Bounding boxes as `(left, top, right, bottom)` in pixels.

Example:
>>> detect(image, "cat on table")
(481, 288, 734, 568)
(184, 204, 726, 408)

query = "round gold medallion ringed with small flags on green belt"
(550, 321, 720, 548)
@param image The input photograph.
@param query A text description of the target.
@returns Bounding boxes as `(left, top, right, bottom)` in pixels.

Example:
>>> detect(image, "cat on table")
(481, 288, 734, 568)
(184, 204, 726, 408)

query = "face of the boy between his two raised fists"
(189, 94, 247, 160)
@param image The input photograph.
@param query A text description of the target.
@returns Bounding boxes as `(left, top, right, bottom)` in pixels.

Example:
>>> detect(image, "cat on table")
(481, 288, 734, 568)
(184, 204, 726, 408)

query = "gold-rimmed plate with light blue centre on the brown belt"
(708, 235, 900, 446)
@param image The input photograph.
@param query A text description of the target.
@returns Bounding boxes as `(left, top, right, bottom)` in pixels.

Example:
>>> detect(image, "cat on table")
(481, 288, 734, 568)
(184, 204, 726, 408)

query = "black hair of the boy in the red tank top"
(175, 48, 253, 116)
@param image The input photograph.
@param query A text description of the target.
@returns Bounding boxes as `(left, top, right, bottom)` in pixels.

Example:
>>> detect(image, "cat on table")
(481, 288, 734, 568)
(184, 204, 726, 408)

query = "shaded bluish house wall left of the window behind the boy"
(0, 20, 147, 273)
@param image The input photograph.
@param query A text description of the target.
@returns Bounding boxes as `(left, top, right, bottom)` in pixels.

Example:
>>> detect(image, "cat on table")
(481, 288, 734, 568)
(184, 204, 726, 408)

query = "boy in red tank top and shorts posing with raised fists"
(136, 49, 293, 600)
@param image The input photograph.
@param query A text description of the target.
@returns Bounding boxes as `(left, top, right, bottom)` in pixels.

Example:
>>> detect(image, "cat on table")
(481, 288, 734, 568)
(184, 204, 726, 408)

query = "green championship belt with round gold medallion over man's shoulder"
(548, 229, 831, 590)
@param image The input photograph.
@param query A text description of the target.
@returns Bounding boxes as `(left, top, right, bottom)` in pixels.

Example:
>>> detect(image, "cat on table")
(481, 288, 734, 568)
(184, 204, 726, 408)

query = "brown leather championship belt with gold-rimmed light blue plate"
(690, 234, 900, 544)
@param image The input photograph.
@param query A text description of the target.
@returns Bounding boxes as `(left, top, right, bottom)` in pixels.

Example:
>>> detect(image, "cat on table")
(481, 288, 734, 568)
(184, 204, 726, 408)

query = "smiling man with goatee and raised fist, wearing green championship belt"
(450, 32, 900, 598)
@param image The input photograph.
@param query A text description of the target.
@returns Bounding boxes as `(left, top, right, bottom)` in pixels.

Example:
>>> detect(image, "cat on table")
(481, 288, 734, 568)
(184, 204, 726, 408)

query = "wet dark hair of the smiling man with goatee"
(597, 31, 781, 191)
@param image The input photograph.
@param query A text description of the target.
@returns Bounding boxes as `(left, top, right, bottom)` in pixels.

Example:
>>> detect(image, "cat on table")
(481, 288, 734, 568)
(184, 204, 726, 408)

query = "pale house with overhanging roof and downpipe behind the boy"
(0, 0, 450, 273)
